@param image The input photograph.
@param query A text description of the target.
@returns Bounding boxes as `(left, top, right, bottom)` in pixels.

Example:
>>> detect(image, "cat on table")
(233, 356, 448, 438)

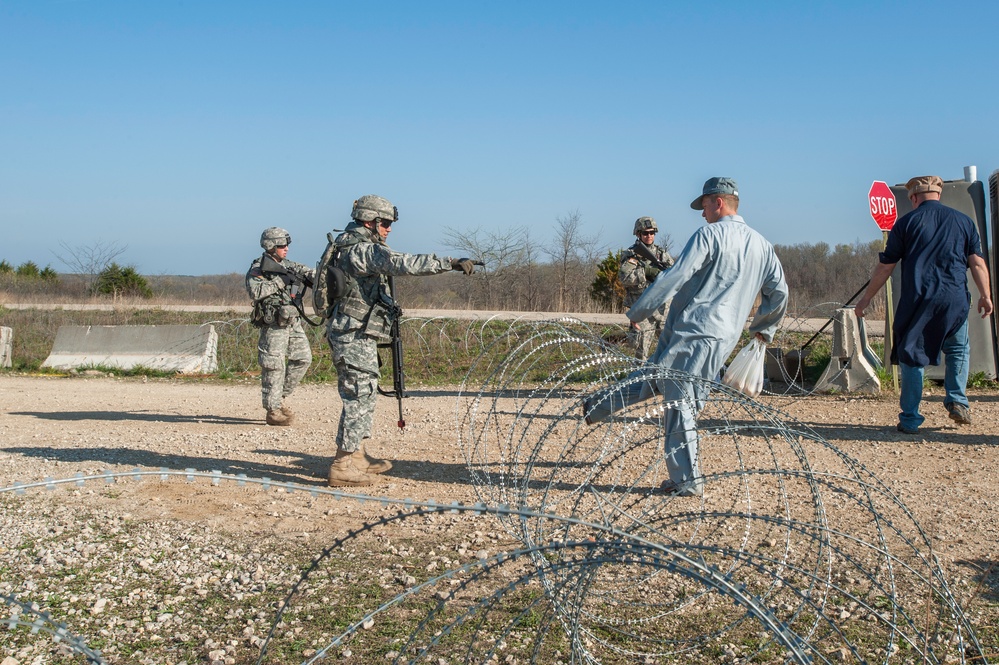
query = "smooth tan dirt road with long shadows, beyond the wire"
(0, 376, 999, 563)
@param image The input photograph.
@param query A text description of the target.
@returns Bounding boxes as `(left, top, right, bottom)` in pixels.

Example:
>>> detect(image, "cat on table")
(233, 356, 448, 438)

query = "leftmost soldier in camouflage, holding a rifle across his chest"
(246, 226, 316, 425)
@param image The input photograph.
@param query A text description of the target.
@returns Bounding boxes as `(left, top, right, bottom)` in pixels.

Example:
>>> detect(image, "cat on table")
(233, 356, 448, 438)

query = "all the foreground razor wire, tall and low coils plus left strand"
(0, 319, 987, 663)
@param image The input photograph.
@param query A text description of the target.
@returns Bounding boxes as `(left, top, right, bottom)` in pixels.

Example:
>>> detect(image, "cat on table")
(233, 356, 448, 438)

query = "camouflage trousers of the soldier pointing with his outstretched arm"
(326, 330, 378, 453)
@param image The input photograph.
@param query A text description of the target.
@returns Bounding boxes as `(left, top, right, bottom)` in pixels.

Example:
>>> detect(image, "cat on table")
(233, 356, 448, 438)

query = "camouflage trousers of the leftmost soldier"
(257, 321, 312, 411)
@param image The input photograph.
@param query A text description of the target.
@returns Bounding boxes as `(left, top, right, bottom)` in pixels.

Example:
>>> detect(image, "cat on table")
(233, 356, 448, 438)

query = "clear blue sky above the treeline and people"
(0, 0, 999, 275)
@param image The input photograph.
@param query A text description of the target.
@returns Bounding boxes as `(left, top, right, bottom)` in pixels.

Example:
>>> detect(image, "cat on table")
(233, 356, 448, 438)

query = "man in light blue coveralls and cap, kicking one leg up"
(583, 178, 787, 496)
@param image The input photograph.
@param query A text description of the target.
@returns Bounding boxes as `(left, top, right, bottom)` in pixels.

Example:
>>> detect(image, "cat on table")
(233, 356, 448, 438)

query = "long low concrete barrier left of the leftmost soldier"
(42, 324, 218, 374)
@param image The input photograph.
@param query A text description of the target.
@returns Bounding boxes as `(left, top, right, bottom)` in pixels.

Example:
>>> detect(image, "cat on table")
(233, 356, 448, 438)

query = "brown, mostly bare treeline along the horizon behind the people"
(0, 240, 884, 316)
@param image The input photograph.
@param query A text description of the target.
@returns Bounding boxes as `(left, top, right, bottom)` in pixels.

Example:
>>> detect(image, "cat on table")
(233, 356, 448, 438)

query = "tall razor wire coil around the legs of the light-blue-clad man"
(458, 319, 984, 662)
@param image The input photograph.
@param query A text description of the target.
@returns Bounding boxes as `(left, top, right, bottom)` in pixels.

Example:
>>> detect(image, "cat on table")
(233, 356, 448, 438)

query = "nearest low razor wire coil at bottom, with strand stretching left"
(0, 468, 987, 663)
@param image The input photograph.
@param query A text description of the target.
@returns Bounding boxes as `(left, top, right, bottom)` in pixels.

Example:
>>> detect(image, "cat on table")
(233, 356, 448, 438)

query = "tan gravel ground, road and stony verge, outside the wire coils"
(0, 375, 999, 665)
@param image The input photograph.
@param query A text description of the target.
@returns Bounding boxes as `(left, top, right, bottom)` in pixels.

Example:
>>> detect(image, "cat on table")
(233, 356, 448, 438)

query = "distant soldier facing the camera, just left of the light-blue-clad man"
(617, 217, 673, 360)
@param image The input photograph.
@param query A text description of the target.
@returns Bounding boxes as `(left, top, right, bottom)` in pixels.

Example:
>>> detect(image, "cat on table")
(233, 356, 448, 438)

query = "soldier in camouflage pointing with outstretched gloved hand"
(326, 195, 474, 487)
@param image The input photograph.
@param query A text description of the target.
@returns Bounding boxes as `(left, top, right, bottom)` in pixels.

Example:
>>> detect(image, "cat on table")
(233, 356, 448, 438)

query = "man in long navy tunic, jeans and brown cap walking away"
(854, 175, 992, 434)
